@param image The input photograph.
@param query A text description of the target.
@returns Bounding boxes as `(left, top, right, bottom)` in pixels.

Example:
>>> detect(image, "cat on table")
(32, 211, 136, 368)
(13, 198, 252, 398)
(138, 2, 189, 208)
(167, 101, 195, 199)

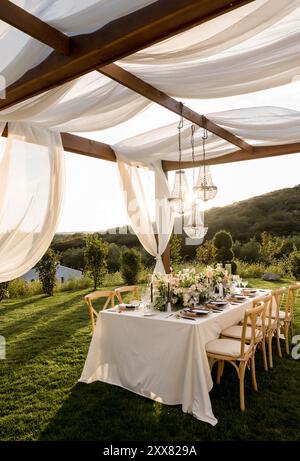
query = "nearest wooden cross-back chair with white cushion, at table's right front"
(205, 301, 266, 411)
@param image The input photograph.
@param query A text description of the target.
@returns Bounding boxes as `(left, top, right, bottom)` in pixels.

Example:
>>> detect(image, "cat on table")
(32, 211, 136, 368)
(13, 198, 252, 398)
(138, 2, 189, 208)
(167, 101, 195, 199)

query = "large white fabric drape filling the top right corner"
(120, 0, 300, 99)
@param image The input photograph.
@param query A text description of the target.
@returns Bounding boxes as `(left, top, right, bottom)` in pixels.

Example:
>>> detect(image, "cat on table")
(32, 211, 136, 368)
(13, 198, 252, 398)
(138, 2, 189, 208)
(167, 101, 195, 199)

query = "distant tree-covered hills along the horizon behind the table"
(52, 185, 300, 253)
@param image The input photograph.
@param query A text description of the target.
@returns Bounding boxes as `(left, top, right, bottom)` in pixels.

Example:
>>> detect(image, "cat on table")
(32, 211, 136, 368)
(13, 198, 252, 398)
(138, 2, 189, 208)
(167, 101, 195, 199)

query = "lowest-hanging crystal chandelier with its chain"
(183, 125, 208, 240)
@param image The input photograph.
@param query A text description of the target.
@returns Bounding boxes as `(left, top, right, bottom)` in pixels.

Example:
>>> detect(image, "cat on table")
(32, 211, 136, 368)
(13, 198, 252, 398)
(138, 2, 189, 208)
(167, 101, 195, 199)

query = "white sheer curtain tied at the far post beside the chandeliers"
(117, 156, 174, 274)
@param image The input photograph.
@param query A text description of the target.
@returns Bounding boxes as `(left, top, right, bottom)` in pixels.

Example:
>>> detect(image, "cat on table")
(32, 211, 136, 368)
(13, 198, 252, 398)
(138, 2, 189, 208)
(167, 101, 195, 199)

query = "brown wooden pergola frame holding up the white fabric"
(0, 0, 300, 271)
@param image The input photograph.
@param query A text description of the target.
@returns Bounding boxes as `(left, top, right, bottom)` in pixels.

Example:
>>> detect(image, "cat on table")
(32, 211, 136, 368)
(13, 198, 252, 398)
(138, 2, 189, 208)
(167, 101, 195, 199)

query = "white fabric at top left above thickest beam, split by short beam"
(0, 0, 154, 85)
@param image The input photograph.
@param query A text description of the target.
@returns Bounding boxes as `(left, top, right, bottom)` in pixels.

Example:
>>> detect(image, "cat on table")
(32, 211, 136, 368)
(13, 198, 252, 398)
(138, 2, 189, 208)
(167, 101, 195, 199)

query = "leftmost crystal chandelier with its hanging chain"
(169, 108, 188, 215)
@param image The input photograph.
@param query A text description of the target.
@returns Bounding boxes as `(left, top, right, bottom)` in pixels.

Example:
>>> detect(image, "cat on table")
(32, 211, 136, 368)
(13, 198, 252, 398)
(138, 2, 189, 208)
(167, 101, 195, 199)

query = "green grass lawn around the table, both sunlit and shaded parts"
(0, 279, 300, 441)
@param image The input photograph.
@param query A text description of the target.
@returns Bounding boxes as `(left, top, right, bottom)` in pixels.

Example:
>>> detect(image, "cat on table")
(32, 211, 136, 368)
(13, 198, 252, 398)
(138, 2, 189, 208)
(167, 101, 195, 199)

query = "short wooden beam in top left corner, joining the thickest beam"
(0, 0, 71, 55)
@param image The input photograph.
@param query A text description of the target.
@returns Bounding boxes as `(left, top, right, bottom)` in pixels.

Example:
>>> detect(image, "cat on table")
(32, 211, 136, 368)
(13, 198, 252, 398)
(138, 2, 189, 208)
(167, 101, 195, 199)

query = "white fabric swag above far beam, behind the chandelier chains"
(114, 107, 300, 164)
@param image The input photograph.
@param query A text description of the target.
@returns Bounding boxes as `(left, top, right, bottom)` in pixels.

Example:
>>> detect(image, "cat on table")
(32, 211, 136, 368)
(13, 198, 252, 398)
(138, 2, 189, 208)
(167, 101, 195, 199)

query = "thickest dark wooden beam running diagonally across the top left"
(0, 0, 253, 110)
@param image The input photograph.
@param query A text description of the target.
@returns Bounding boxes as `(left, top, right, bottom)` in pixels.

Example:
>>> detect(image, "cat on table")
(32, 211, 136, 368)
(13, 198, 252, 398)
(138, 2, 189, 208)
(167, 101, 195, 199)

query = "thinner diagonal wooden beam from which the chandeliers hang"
(99, 64, 253, 152)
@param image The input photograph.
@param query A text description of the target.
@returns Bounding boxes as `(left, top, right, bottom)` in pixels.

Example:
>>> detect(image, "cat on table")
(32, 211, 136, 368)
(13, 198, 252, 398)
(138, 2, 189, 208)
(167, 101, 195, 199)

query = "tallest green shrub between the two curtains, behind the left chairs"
(84, 233, 108, 290)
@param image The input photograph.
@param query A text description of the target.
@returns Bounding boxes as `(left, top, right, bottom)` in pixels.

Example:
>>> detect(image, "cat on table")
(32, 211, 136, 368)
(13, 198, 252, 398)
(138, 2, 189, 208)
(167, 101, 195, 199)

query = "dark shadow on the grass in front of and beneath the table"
(39, 344, 299, 441)
